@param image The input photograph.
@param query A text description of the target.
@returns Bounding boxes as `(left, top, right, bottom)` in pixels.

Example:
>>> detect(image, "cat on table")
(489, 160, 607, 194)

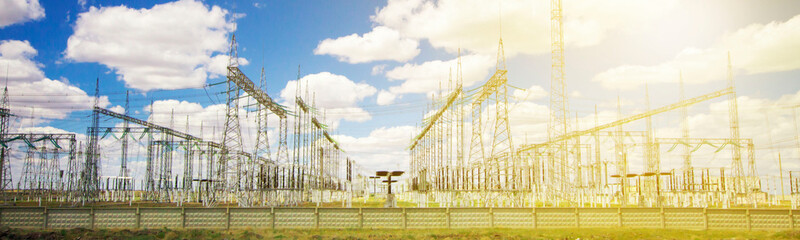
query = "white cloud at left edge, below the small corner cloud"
(0, 40, 109, 125)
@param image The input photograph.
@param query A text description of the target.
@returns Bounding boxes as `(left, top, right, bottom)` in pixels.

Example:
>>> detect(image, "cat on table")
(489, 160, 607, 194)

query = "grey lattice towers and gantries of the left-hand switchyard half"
(0, 35, 367, 207)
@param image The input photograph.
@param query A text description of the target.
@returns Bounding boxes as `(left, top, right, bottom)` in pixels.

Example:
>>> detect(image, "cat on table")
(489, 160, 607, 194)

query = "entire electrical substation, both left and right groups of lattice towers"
(0, 0, 800, 212)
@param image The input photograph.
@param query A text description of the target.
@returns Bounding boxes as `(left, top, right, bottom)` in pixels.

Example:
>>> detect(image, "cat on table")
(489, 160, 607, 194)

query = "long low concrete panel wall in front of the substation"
(0, 207, 800, 230)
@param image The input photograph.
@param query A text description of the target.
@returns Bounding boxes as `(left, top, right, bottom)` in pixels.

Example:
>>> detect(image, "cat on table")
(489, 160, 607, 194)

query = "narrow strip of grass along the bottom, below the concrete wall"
(0, 227, 800, 239)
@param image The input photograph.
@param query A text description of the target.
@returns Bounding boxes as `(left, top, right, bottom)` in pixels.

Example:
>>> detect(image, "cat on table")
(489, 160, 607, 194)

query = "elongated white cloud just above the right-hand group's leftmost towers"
(386, 54, 496, 94)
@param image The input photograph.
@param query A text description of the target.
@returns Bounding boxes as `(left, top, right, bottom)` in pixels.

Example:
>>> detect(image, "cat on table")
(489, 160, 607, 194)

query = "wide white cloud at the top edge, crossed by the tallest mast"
(372, 0, 675, 56)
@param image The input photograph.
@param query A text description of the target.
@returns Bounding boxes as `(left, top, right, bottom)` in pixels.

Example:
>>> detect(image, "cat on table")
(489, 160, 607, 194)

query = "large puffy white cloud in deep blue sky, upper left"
(65, 0, 235, 91)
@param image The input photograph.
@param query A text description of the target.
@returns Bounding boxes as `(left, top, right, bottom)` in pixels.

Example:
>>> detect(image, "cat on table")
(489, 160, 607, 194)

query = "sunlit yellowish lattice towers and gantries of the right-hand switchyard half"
(405, 0, 768, 208)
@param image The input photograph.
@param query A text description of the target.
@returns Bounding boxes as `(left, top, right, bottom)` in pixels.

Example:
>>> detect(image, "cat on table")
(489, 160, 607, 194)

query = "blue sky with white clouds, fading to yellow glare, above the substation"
(0, 0, 800, 184)
